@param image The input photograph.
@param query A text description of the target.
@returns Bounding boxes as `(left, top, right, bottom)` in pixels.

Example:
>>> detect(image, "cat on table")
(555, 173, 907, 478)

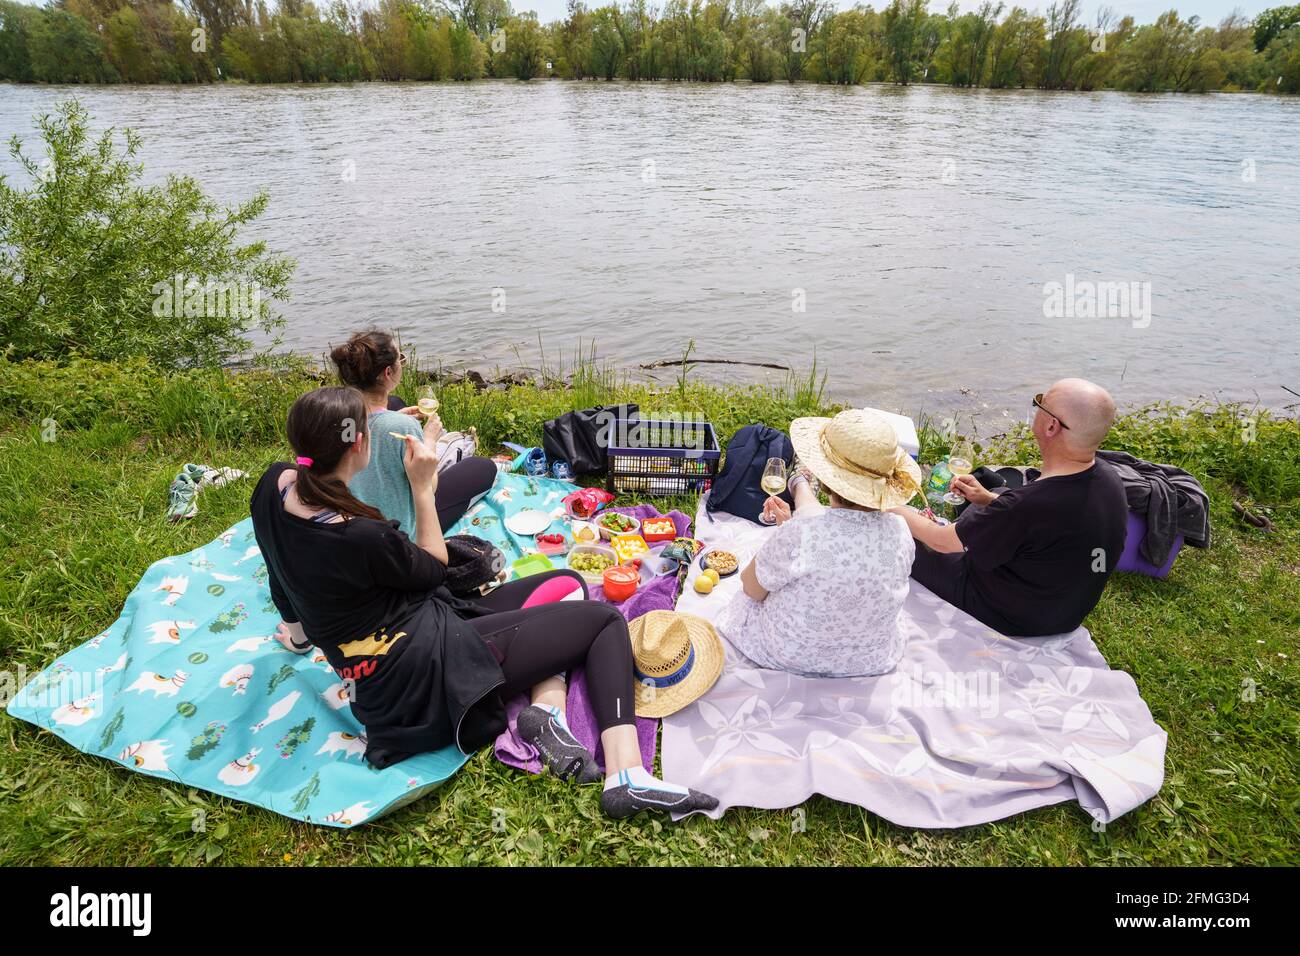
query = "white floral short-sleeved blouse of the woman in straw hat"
(718, 509, 915, 678)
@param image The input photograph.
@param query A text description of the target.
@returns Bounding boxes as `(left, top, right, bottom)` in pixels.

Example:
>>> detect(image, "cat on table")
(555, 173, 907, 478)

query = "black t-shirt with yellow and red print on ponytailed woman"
(250, 464, 503, 766)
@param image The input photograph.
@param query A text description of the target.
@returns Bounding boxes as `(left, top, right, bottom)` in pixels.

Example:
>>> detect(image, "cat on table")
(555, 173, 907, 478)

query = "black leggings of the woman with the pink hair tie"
(468, 570, 636, 731)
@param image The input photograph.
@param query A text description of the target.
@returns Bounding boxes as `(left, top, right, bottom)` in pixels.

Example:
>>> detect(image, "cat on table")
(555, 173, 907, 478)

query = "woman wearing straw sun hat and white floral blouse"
(718, 408, 922, 678)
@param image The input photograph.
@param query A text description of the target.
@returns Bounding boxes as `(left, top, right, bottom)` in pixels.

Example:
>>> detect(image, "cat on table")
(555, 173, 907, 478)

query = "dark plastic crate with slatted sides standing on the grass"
(605, 419, 722, 498)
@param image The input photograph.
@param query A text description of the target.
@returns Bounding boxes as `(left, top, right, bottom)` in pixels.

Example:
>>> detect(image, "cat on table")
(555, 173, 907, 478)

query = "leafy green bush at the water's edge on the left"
(0, 100, 294, 368)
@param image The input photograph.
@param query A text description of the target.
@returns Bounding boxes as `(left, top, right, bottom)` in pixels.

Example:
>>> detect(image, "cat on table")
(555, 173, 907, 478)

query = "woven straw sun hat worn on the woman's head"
(790, 408, 920, 510)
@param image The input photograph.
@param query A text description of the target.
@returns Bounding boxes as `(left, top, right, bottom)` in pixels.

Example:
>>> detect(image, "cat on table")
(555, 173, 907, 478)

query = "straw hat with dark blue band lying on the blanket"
(628, 611, 724, 717)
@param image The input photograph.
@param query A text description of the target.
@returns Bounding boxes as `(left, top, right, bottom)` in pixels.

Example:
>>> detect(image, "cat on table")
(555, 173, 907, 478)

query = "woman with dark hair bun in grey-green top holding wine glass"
(330, 330, 497, 536)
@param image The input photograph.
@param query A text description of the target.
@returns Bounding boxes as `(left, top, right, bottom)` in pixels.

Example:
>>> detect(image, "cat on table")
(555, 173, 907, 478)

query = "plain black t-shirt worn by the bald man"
(957, 460, 1128, 636)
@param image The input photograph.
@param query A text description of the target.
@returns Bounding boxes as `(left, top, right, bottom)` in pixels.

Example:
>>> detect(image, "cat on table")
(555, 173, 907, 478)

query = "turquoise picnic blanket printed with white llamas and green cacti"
(8, 475, 573, 827)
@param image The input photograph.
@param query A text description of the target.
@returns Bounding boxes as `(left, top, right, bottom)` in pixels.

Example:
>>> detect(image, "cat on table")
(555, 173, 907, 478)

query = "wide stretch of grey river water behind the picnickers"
(0, 81, 1300, 420)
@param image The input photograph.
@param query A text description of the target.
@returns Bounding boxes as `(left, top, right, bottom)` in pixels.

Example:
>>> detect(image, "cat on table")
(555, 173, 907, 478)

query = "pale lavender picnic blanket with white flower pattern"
(662, 501, 1166, 827)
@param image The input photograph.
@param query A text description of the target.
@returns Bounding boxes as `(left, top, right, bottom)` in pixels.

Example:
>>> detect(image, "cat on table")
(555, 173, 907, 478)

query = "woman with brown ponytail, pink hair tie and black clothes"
(251, 388, 718, 817)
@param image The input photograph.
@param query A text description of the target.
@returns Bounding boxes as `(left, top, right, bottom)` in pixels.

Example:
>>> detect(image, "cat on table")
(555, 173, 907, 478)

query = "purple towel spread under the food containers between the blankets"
(495, 505, 690, 774)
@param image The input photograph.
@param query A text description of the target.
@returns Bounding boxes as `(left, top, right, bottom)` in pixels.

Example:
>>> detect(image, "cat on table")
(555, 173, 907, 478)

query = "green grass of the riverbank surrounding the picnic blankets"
(0, 354, 1300, 865)
